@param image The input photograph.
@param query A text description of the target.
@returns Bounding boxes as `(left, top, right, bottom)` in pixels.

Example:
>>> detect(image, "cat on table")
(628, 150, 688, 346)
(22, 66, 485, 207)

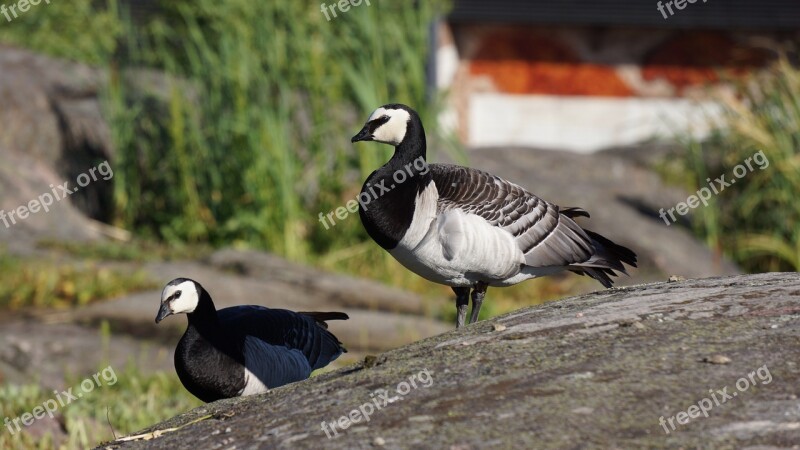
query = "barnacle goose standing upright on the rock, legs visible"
(352, 104, 636, 328)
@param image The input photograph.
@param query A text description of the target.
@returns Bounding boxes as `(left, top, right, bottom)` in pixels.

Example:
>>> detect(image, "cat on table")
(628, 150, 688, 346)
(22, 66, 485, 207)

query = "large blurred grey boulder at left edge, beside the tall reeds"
(0, 46, 114, 253)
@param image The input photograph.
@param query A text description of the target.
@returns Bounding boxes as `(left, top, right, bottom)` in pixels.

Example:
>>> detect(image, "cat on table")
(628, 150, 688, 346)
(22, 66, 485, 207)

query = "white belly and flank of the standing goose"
(389, 183, 539, 287)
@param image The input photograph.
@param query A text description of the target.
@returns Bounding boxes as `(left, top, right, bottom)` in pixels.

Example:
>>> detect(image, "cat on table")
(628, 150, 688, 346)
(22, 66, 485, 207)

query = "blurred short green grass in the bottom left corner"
(0, 324, 202, 450)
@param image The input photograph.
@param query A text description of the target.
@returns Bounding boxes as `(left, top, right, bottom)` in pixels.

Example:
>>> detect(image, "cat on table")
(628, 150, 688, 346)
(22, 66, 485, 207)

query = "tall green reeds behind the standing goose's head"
(107, 0, 456, 259)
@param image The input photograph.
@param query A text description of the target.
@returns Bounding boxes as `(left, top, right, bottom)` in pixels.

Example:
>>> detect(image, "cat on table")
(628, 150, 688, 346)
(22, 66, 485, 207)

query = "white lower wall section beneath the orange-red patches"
(466, 93, 720, 153)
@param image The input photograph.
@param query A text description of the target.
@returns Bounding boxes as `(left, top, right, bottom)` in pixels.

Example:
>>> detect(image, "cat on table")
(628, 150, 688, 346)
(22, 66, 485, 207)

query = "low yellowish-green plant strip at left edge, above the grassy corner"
(0, 254, 158, 310)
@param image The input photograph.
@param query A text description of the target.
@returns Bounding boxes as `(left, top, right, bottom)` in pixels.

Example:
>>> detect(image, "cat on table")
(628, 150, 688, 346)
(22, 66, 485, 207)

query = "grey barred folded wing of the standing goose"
(430, 164, 595, 267)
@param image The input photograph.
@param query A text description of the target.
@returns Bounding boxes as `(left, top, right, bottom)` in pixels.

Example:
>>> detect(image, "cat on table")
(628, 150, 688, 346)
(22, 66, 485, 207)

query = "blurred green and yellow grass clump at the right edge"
(661, 59, 800, 272)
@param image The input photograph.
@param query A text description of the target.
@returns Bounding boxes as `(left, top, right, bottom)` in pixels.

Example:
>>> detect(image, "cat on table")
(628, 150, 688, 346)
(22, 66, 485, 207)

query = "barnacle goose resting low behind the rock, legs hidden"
(156, 278, 348, 402)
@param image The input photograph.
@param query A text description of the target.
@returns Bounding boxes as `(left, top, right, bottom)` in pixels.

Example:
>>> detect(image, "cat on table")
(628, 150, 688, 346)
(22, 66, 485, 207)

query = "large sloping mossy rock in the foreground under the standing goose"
(101, 273, 800, 449)
